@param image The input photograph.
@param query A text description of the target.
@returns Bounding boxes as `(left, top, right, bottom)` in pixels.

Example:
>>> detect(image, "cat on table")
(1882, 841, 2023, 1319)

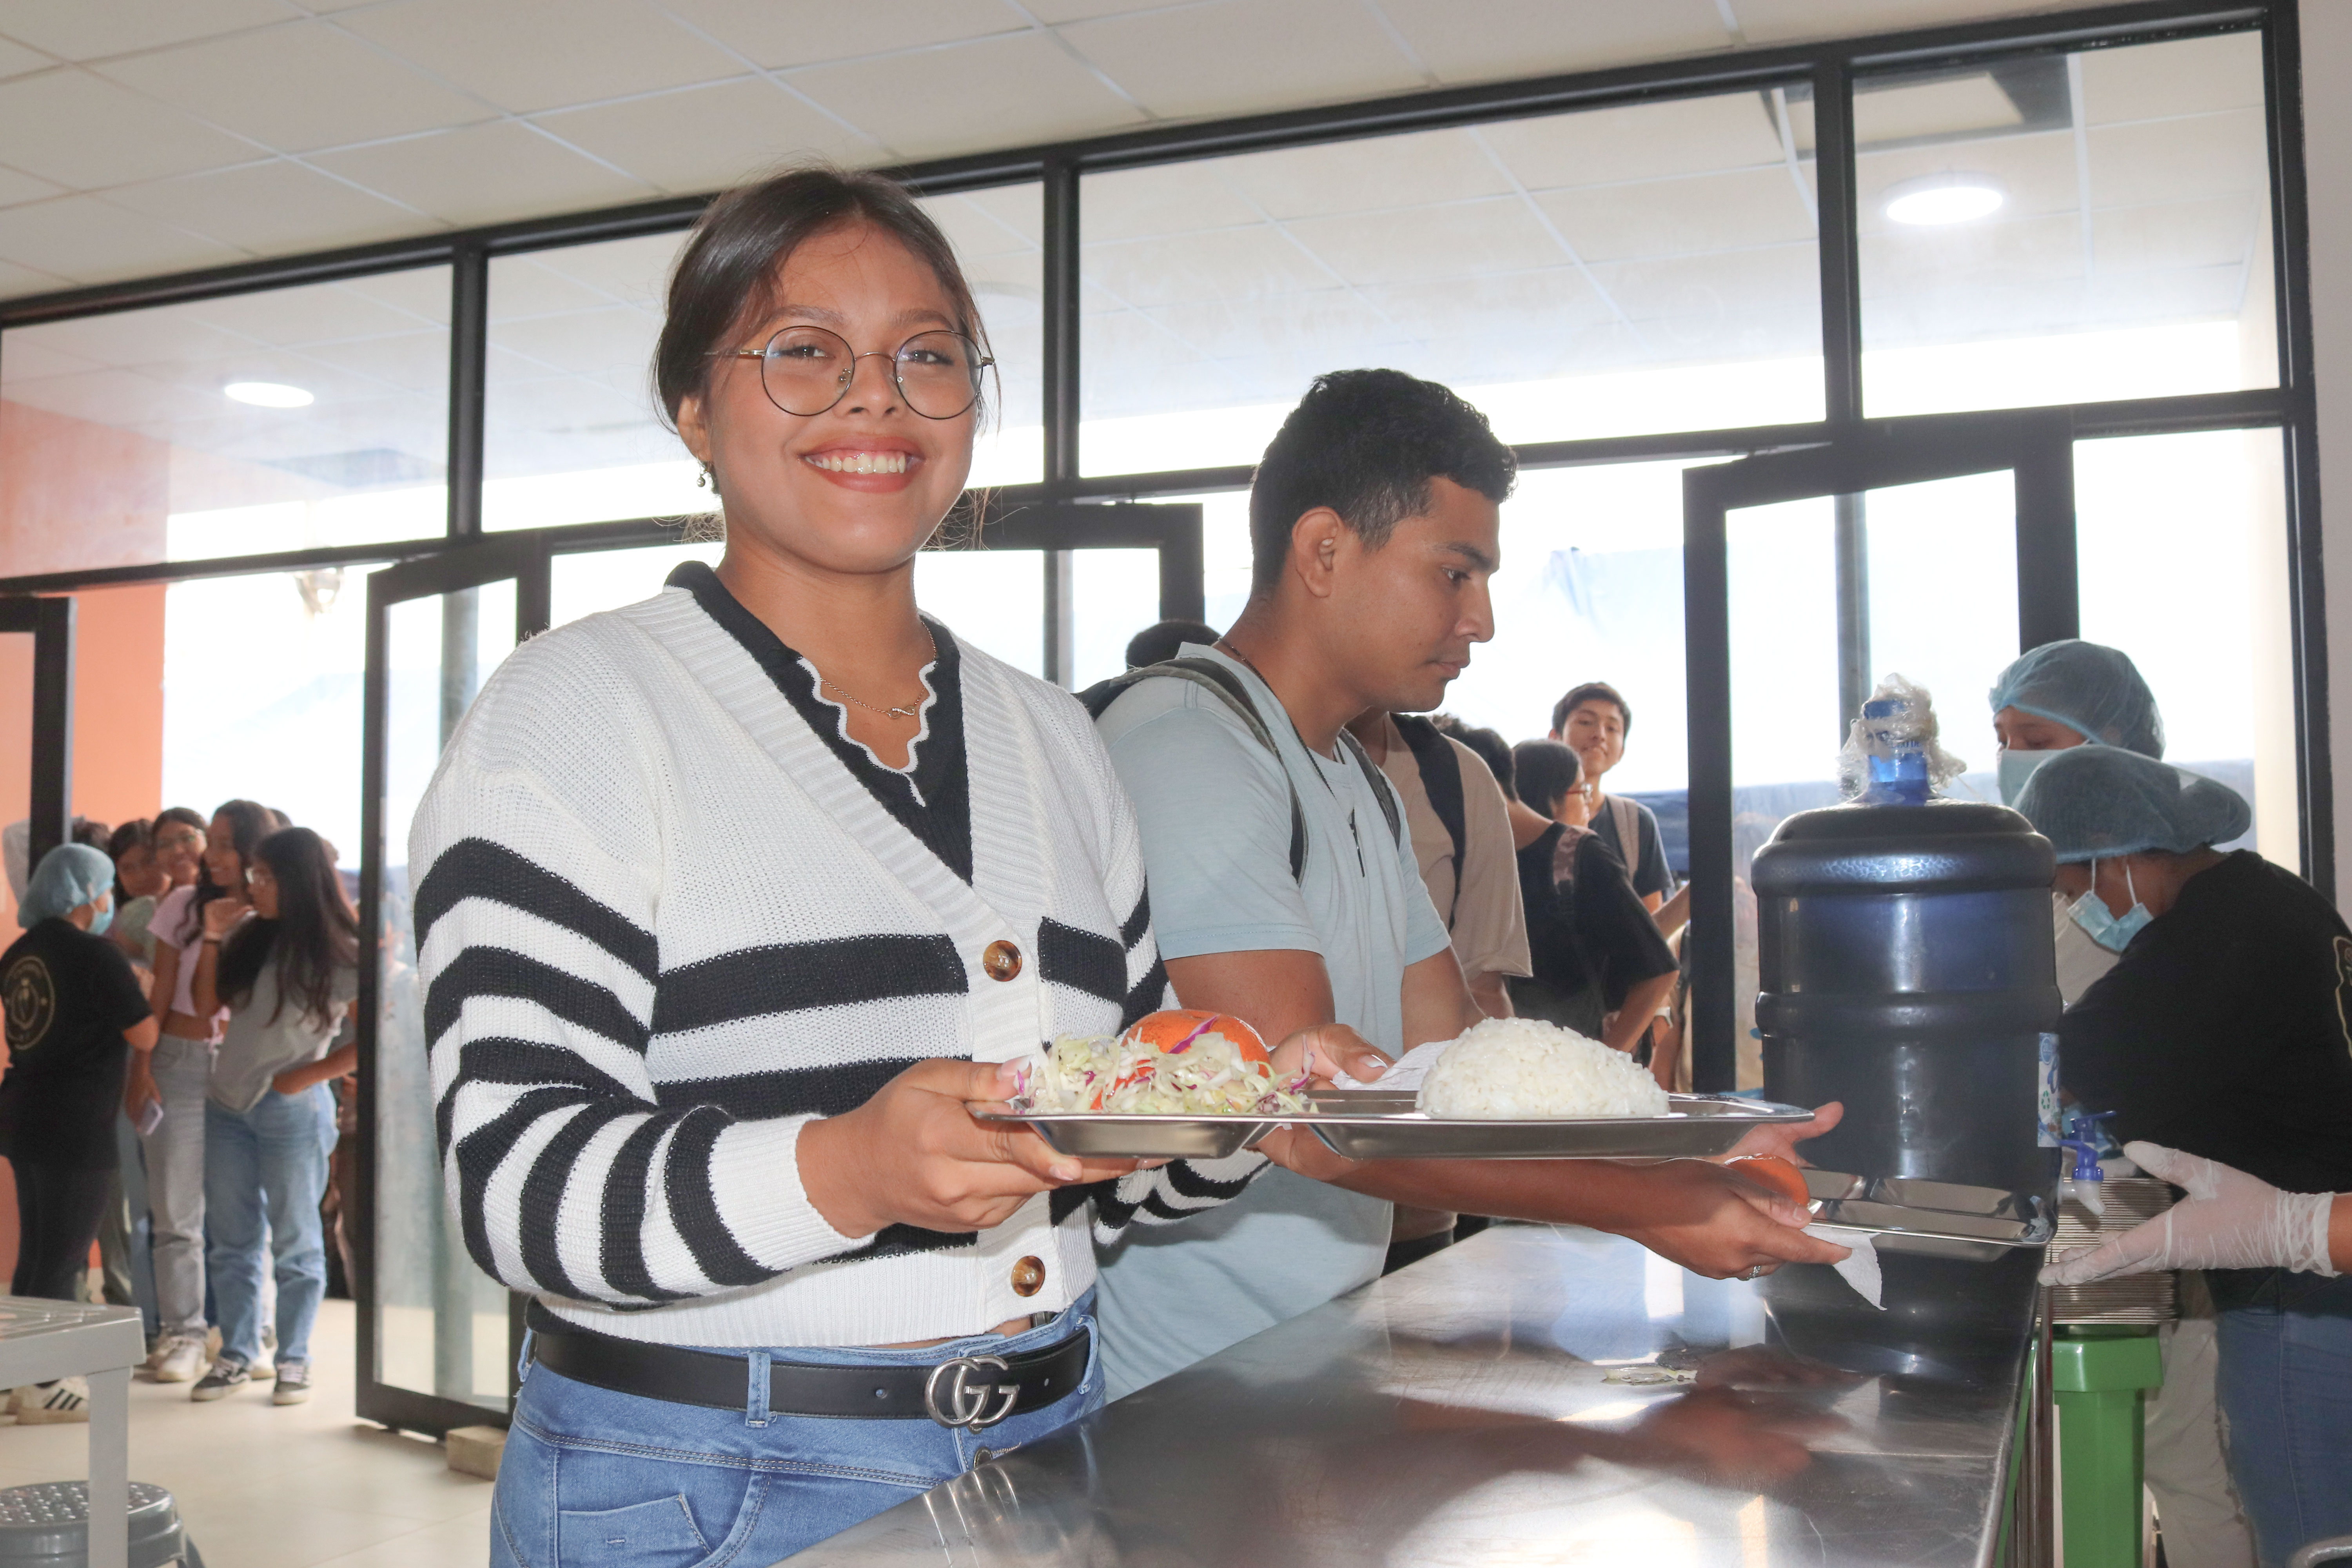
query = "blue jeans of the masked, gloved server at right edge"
(2213, 1269, 2352, 1568)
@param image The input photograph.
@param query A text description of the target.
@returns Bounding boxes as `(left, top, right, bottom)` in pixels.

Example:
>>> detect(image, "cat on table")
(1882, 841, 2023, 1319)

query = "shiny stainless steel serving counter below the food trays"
(793, 1227, 2039, 1568)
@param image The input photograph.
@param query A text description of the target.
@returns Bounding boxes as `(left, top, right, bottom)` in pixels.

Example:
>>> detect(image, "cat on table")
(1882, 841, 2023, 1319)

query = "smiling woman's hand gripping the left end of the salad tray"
(800, 1060, 1136, 1236)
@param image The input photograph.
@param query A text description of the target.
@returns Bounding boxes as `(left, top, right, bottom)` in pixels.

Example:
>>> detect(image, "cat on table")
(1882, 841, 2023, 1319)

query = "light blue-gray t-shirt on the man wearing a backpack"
(1096, 646, 1446, 1399)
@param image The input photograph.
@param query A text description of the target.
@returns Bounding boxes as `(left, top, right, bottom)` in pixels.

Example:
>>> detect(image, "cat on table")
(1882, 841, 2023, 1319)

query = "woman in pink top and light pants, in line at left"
(122, 799, 270, 1382)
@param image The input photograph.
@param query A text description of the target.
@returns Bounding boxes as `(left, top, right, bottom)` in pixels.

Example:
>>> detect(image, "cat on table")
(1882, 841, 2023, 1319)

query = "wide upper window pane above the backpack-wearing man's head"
(1080, 92, 1823, 475)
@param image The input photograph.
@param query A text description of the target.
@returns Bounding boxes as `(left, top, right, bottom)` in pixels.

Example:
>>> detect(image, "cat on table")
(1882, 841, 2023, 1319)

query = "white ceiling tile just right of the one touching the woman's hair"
(793, 33, 1143, 158)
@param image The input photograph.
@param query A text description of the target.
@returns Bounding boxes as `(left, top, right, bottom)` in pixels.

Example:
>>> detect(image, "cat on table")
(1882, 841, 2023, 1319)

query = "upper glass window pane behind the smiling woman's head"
(482, 186, 1044, 529)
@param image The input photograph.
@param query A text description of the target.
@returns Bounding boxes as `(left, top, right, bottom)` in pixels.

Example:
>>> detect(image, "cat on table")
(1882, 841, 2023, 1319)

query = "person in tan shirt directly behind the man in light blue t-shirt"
(1348, 708, 1529, 1274)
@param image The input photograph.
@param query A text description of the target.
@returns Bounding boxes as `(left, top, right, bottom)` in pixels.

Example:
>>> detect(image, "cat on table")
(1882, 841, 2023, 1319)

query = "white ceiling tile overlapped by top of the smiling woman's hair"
(536, 78, 880, 193)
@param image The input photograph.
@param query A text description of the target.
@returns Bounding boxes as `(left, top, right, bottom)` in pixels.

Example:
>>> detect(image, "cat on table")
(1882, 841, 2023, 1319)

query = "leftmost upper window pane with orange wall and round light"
(0, 268, 449, 576)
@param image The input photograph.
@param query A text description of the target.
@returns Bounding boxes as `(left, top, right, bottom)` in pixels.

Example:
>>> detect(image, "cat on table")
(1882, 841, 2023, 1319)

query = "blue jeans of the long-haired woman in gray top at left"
(205, 1084, 334, 1366)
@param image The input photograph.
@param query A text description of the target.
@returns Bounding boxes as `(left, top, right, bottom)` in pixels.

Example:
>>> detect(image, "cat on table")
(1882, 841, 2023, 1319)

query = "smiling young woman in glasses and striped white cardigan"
(409, 169, 1364, 1563)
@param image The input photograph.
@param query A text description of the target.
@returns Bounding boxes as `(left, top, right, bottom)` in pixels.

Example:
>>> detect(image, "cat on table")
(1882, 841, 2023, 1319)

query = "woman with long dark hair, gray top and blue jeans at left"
(193, 828, 360, 1406)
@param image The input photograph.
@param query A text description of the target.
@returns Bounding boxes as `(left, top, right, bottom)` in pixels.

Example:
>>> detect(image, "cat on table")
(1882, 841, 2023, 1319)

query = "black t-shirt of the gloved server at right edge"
(2058, 849, 2352, 1192)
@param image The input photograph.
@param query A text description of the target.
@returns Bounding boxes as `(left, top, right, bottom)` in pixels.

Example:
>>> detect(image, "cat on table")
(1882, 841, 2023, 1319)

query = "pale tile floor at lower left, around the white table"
(0, 1300, 489, 1568)
